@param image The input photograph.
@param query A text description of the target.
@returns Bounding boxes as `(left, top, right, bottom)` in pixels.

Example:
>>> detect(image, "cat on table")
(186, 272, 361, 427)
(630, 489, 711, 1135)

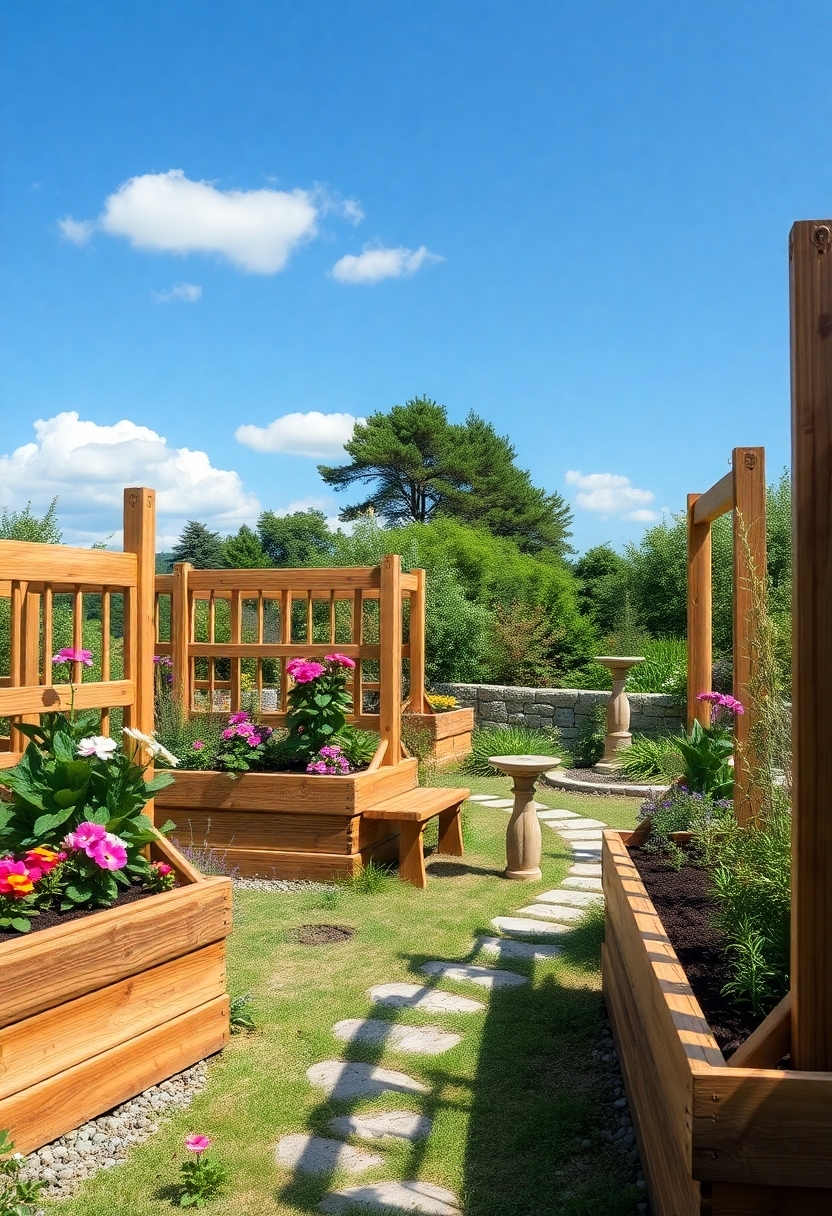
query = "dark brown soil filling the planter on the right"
(630, 849, 759, 1055)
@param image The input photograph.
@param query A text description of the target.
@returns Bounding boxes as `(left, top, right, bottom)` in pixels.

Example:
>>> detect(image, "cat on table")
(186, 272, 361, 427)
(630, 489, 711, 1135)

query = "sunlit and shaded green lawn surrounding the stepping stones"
(53, 775, 642, 1216)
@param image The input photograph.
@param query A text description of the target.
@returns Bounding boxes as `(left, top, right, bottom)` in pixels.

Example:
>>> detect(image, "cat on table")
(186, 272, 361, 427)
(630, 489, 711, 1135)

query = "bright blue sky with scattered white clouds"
(0, 0, 832, 550)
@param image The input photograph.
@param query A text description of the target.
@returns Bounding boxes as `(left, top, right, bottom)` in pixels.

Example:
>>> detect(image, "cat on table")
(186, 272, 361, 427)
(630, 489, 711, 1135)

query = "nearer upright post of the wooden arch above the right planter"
(732, 447, 766, 823)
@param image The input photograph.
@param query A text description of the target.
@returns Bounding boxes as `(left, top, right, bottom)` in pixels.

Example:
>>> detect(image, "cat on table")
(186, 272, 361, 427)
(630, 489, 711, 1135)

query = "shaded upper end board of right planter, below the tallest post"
(692, 1068, 832, 1186)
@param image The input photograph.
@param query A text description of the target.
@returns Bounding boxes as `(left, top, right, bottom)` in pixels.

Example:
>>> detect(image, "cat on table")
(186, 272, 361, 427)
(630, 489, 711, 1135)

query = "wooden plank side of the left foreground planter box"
(0, 846, 231, 1153)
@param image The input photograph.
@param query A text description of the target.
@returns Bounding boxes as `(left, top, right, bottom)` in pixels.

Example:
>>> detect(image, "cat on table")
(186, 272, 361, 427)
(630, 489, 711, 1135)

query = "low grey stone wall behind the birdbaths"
(434, 683, 685, 743)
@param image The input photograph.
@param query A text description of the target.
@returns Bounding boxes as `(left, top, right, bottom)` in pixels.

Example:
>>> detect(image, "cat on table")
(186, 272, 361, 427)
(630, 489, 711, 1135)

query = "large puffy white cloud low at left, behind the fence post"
(0, 411, 260, 544)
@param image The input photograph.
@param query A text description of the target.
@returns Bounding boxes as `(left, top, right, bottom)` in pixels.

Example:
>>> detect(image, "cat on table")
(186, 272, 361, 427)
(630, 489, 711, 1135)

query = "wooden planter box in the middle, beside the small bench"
(156, 760, 418, 880)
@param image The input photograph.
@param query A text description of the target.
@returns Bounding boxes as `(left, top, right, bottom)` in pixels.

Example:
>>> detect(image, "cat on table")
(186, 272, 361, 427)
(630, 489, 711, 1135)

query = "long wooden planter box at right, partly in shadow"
(603, 831, 832, 1216)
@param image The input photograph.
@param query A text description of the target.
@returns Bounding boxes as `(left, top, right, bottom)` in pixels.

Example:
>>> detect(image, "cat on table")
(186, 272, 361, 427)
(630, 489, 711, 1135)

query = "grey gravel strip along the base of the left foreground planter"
(21, 1060, 208, 1199)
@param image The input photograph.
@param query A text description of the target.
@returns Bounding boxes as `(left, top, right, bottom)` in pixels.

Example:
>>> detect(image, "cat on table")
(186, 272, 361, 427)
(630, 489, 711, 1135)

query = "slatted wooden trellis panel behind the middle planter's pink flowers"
(154, 554, 428, 765)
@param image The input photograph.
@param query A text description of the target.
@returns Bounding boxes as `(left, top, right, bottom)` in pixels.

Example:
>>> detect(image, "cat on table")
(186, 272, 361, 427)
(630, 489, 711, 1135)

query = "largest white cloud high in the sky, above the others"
(60, 169, 323, 275)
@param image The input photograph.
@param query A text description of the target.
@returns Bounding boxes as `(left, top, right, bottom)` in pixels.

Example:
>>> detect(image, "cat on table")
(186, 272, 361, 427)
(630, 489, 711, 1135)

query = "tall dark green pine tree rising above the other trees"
(319, 396, 572, 556)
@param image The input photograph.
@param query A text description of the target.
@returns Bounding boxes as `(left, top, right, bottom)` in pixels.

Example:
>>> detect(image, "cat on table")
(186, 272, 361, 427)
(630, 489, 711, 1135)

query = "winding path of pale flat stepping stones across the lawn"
(275, 794, 617, 1216)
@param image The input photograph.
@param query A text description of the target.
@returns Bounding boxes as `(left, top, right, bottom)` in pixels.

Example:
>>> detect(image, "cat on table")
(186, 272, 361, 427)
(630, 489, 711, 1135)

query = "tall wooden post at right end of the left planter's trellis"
(124, 486, 156, 820)
